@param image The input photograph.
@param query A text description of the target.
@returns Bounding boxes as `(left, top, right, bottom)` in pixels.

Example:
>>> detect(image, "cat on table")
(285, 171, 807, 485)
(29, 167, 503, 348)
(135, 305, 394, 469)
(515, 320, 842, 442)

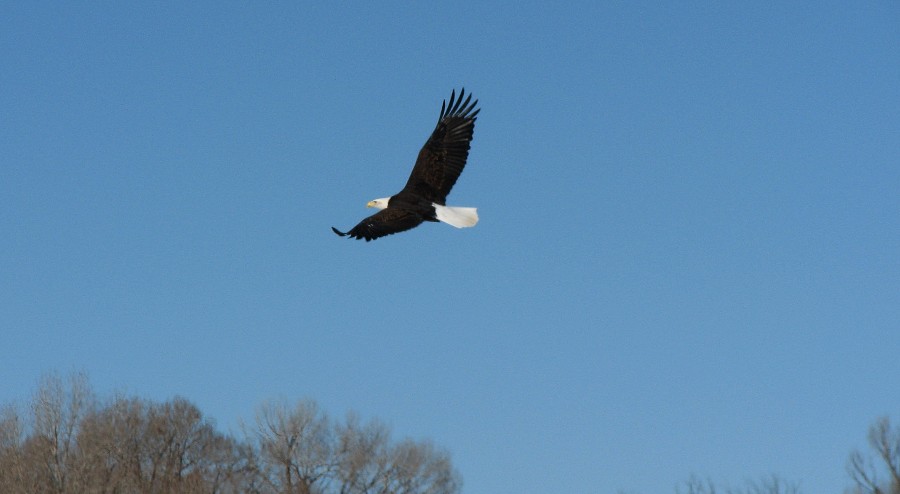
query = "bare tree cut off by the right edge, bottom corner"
(847, 417, 900, 494)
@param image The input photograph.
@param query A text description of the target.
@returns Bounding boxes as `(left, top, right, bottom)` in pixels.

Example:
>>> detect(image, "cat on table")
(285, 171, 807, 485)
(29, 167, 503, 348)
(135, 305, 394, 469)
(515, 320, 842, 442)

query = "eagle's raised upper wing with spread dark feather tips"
(401, 89, 481, 204)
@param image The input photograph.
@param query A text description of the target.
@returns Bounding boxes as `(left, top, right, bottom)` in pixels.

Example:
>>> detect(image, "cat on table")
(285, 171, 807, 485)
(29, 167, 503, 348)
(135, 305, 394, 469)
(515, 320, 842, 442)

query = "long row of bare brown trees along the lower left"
(0, 374, 461, 494)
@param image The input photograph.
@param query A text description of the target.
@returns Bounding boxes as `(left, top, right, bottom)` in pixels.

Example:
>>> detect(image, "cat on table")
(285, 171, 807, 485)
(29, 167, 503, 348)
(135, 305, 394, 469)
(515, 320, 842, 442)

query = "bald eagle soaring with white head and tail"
(331, 89, 481, 242)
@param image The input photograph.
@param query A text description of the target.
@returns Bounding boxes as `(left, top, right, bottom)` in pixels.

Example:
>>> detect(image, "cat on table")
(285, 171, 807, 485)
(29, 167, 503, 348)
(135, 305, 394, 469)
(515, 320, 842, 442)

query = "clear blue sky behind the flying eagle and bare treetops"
(0, 1, 900, 494)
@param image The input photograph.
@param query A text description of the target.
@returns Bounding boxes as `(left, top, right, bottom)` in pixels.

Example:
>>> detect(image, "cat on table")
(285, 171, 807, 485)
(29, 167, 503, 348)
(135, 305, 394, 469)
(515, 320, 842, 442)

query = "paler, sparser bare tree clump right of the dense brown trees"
(249, 400, 460, 494)
